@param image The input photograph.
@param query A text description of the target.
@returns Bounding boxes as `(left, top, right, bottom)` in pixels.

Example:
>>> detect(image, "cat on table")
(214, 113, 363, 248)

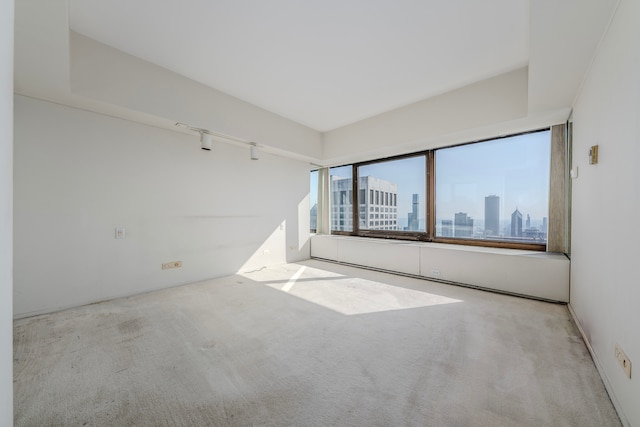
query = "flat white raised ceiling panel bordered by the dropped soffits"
(69, 0, 529, 131)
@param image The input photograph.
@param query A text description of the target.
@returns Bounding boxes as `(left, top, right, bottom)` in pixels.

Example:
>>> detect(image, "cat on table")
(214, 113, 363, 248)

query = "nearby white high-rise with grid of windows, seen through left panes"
(331, 176, 398, 231)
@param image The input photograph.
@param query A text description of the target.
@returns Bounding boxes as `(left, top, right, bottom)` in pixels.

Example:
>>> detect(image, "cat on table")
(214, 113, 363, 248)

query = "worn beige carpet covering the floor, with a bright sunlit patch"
(14, 260, 620, 426)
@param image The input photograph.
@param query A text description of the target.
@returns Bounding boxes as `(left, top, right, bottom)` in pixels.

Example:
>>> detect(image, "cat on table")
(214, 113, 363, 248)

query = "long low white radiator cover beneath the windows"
(311, 235, 570, 302)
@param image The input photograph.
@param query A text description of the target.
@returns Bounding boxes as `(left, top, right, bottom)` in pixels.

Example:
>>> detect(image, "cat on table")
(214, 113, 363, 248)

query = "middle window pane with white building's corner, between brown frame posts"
(358, 156, 426, 231)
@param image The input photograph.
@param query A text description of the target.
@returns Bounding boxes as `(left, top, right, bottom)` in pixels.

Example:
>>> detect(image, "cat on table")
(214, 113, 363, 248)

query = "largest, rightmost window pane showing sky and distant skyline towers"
(435, 130, 550, 243)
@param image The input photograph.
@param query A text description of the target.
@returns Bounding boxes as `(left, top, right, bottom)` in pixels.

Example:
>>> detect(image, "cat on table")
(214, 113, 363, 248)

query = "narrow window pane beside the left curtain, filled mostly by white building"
(329, 166, 353, 231)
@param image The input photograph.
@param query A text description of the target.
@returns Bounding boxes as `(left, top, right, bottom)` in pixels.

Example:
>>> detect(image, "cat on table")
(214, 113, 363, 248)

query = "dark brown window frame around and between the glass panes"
(331, 126, 552, 251)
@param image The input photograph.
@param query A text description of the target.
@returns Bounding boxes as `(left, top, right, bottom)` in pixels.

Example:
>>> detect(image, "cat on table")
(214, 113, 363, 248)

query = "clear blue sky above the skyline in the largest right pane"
(436, 131, 550, 226)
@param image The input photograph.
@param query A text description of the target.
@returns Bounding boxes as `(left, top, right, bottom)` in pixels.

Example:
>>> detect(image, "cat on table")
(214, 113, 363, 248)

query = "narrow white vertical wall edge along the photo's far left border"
(0, 0, 13, 426)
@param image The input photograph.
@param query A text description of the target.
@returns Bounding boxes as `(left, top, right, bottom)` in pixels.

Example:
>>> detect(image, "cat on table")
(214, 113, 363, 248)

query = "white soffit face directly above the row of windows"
(324, 68, 528, 163)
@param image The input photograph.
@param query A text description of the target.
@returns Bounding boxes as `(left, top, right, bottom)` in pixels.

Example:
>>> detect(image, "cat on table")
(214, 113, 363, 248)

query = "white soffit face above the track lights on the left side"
(69, 31, 321, 158)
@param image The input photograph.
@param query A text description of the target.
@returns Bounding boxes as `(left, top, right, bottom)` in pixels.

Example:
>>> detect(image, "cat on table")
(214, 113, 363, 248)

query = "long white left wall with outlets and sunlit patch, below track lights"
(14, 96, 309, 316)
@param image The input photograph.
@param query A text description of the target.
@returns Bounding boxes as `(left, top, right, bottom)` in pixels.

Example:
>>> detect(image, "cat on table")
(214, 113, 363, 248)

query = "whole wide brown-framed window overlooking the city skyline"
(322, 129, 551, 250)
